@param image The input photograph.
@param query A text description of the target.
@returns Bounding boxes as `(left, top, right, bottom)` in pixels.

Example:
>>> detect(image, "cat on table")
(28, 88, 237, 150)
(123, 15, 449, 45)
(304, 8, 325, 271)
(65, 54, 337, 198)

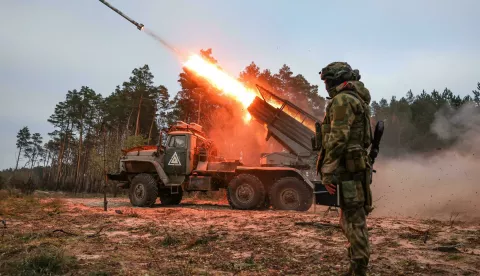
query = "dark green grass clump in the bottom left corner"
(11, 246, 77, 276)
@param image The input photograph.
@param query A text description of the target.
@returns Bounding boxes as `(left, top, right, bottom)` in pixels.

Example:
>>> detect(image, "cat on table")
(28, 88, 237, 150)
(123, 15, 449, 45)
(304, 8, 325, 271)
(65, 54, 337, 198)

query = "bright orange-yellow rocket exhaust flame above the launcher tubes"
(184, 55, 257, 122)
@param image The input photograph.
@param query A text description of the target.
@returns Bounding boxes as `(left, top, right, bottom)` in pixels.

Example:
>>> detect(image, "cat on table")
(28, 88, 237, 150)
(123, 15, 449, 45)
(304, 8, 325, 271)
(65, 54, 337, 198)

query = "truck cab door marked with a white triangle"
(164, 135, 188, 175)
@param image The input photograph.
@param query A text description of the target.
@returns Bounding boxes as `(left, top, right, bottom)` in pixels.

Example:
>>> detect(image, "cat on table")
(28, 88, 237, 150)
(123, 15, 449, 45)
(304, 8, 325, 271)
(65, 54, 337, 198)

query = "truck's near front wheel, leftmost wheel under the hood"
(129, 173, 158, 207)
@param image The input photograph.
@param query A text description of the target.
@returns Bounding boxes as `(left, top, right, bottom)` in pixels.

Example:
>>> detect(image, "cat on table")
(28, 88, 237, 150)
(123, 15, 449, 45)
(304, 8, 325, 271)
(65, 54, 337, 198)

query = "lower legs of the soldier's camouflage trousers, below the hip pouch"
(340, 207, 370, 275)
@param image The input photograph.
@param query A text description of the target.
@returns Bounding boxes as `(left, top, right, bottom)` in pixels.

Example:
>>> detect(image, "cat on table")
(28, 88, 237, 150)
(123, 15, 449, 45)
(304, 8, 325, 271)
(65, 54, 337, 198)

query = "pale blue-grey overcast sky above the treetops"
(0, 0, 480, 169)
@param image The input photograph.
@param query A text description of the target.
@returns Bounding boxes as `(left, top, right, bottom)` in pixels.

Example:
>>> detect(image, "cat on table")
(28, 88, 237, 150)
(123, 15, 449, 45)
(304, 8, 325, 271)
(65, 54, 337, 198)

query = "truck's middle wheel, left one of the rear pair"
(227, 174, 265, 210)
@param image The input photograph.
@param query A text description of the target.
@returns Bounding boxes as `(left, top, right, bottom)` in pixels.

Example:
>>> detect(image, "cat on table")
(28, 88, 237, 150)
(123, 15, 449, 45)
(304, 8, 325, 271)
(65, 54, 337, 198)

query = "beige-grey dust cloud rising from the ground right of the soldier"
(372, 102, 480, 220)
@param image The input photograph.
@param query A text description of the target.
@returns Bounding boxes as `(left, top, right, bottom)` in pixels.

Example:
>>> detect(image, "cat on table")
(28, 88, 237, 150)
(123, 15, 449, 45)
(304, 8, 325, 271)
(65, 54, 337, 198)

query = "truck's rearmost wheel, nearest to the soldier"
(270, 177, 313, 211)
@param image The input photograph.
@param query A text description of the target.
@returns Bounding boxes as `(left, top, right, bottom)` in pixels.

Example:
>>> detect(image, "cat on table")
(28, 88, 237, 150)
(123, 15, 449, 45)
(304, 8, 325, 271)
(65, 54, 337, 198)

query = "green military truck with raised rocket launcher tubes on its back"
(108, 86, 338, 211)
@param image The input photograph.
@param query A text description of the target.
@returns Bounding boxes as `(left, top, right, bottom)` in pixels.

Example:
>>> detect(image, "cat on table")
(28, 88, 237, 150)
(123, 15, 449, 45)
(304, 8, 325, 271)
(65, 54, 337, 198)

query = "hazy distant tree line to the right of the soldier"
(371, 82, 480, 157)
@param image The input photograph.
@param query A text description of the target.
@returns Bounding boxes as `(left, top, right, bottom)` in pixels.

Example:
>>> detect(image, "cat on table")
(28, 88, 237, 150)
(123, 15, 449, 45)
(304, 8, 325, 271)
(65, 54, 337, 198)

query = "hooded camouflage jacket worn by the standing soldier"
(321, 81, 372, 174)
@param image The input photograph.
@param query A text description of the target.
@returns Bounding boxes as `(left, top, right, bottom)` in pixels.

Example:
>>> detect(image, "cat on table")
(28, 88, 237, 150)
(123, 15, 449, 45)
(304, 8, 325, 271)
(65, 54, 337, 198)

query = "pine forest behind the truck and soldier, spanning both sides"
(0, 49, 480, 193)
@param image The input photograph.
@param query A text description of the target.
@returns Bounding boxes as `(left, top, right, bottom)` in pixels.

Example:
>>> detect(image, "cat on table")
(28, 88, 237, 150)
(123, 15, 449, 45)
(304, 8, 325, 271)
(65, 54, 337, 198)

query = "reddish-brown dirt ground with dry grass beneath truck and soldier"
(0, 192, 480, 275)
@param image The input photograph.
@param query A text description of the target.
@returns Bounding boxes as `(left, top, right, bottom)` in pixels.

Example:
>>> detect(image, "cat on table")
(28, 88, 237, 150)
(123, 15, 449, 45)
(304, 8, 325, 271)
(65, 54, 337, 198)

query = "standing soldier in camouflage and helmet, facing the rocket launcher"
(317, 62, 372, 275)
